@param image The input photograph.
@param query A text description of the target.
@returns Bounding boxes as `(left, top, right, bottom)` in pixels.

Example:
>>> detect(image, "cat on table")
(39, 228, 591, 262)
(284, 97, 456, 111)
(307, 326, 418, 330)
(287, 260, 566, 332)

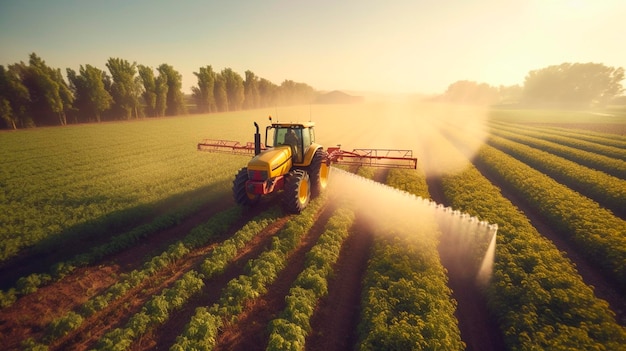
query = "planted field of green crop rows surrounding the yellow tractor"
(0, 100, 626, 350)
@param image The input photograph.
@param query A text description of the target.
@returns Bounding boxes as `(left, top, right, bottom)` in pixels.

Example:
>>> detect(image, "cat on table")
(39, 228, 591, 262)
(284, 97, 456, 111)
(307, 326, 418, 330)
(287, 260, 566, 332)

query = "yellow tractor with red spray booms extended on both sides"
(198, 117, 417, 213)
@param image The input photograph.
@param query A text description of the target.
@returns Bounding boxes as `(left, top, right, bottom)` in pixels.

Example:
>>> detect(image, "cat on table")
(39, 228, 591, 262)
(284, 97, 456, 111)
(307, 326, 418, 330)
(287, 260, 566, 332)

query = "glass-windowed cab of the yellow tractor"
(265, 122, 315, 164)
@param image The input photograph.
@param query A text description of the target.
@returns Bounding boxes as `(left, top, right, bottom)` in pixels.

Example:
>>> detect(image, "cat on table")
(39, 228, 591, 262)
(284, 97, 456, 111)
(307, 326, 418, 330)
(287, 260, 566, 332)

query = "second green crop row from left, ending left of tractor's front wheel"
(36, 208, 241, 343)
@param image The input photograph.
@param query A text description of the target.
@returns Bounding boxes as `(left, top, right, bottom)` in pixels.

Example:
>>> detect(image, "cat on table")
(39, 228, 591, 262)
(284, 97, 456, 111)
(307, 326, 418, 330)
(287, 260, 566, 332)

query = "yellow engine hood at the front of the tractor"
(248, 145, 292, 180)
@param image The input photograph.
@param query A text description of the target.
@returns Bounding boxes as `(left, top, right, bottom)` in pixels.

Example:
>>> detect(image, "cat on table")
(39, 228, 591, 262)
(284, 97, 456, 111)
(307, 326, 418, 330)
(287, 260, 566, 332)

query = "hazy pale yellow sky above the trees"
(0, 0, 626, 93)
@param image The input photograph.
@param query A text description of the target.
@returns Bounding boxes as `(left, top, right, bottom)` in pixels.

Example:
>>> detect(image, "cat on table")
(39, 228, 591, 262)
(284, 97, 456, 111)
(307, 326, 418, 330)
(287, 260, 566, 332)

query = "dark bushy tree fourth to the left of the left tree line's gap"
(67, 65, 113, 122)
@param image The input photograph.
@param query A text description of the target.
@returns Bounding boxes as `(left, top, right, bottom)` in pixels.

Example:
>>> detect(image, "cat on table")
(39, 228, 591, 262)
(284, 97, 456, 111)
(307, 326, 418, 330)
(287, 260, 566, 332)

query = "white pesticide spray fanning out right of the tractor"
(327, 168, 498, 286)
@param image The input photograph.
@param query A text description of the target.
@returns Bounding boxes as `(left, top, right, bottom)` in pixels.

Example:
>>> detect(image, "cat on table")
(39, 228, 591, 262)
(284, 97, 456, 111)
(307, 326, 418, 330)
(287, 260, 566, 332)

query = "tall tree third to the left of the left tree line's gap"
(106, 58, 141, 119)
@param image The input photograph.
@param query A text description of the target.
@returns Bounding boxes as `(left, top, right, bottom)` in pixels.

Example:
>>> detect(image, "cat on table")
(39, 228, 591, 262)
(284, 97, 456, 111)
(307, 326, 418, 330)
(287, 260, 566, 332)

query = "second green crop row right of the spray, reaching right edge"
(478, 146, 626, 287)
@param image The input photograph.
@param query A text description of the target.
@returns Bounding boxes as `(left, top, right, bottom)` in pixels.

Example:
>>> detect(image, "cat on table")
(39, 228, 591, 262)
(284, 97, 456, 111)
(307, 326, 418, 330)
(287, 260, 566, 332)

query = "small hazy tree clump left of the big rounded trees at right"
(442, 80, 499, 105)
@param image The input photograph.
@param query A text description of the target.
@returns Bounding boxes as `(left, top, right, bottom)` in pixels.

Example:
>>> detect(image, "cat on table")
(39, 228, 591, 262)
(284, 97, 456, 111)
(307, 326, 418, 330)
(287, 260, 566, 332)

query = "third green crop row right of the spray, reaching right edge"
(487, 136, 626, 214)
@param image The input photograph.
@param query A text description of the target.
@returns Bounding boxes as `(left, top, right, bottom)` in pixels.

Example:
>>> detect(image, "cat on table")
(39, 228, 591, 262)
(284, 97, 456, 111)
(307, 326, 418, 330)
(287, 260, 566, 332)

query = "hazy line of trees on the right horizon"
(435, 63, 625, 108)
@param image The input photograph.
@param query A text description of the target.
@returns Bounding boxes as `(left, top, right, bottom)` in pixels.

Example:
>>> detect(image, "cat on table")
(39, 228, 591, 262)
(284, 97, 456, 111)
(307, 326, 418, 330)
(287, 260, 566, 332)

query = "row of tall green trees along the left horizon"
(0, 53, 316, 129)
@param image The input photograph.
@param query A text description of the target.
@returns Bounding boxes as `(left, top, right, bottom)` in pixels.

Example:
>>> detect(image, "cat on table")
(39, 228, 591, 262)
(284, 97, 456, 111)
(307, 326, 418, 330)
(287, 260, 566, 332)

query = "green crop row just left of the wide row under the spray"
(267, 208, 354, 351)
